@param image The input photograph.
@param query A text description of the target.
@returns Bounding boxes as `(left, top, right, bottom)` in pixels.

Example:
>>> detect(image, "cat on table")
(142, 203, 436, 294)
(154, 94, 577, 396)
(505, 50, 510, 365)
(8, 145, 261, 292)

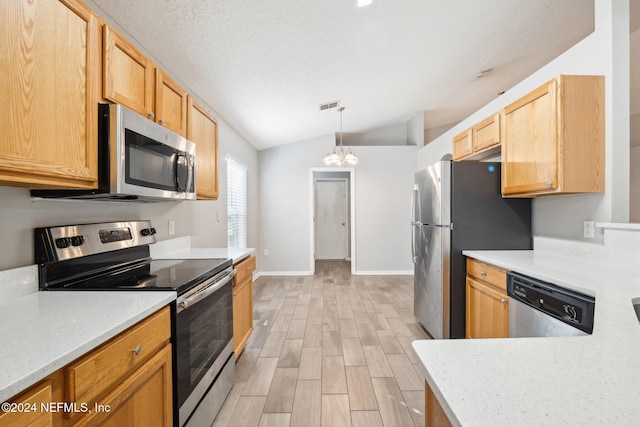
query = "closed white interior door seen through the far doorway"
(316, 180, 348, 259)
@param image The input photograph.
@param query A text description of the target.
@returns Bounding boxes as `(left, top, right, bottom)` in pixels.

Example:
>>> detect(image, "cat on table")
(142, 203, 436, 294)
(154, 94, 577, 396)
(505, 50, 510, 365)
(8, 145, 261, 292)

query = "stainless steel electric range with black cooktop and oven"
(34, 221, 235, 427)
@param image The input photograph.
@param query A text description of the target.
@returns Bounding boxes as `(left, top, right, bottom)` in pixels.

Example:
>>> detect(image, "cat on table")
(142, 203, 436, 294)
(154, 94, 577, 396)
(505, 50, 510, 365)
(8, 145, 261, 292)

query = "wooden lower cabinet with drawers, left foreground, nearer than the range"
(0, 307, 173, 427)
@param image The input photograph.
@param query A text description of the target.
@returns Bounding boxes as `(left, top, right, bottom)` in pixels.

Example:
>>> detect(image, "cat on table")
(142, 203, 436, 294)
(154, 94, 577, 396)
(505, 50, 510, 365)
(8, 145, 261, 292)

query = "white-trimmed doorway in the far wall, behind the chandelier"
(310, 168, 355, 273)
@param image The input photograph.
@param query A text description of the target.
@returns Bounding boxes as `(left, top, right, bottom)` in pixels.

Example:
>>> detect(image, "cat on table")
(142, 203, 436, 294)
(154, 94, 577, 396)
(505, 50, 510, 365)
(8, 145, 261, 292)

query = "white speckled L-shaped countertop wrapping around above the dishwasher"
(413, 251, 640, 426)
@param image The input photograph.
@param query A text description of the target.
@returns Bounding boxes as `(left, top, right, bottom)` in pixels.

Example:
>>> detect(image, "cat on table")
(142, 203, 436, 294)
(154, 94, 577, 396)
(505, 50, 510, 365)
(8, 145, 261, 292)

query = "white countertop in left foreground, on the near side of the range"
(0, 285, 176, 402)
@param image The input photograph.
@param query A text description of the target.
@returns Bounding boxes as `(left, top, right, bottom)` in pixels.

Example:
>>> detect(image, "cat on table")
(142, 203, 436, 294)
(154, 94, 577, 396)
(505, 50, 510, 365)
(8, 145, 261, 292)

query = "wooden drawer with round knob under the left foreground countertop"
(65, 307, 171, 406)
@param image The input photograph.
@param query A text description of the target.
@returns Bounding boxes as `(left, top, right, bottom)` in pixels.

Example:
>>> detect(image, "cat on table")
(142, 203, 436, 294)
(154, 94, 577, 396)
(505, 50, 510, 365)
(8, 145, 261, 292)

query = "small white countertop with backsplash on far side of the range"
(150, 237, 256, 264)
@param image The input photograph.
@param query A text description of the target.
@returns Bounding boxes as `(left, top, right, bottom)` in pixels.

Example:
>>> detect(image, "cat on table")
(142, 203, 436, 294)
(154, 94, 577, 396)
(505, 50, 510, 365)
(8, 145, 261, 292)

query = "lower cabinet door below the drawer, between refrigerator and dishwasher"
(467, 277, 509, 338)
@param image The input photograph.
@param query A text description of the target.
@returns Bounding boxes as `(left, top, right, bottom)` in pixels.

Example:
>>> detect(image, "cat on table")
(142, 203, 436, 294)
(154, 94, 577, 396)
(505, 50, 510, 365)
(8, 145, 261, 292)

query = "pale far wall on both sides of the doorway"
(258, 135, 416, 274)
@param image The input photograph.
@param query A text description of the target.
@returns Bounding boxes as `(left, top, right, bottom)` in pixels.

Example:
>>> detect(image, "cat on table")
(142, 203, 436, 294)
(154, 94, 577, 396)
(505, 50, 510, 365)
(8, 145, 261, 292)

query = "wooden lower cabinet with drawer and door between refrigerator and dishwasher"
(466, 258, 509, 338)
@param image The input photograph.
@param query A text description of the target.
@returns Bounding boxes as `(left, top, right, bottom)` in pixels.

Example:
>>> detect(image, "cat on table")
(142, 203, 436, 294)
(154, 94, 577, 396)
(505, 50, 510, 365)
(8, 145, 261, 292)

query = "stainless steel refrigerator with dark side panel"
(411, 160, 532, 338)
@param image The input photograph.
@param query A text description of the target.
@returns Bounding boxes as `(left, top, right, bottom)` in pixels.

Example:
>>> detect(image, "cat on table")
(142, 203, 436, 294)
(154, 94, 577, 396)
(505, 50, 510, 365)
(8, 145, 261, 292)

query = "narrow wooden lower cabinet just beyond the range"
(233, 255, 256, 359)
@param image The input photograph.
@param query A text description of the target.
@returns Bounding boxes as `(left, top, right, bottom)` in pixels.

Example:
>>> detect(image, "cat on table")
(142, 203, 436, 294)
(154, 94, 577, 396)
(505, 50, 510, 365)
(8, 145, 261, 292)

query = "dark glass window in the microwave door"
(125, 129, 178, 191)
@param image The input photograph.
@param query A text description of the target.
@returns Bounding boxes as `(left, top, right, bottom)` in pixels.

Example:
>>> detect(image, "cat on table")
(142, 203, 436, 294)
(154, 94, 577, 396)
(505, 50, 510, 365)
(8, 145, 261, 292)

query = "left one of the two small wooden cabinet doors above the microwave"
(102, 25, 154, 119)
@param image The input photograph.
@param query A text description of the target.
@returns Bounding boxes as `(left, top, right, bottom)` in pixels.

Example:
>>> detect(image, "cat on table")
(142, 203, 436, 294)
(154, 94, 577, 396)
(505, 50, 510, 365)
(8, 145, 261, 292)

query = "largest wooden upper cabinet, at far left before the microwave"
(0, 0, 100, 188)
